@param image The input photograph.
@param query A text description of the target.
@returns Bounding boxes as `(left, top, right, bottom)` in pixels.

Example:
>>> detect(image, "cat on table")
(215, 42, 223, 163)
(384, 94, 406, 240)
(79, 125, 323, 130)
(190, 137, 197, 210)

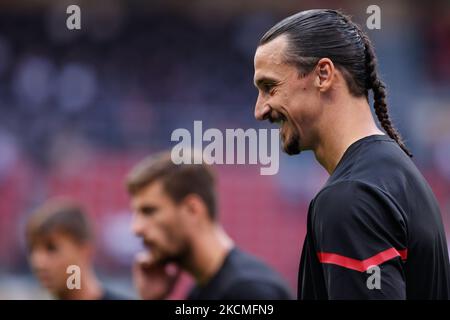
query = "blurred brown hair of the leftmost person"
(26, 198, 93, 249)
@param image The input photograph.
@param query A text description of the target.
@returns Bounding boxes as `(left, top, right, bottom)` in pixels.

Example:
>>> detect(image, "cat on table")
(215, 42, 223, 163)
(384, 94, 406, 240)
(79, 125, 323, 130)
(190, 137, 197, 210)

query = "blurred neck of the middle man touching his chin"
(184, 224, 234, 285)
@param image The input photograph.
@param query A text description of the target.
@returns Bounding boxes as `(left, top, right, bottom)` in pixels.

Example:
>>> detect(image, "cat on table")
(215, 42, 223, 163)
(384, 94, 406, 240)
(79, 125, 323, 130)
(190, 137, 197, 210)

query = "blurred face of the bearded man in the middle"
(131, 181, 188, 263)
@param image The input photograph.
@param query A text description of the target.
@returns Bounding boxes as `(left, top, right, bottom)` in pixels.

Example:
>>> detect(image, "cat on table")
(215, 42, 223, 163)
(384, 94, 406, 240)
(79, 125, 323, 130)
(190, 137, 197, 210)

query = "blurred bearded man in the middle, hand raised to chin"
(127, 153, 292, 300)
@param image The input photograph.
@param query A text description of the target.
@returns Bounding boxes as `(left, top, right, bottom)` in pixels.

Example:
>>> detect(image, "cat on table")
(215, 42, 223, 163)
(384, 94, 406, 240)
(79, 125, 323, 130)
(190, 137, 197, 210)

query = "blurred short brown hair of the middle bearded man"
(126, 152, 216, 220)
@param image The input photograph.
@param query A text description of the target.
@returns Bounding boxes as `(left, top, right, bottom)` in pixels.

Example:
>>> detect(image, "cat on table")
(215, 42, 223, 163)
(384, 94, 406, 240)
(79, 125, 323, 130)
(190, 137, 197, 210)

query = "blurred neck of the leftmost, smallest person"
(58, 271, 103, 300)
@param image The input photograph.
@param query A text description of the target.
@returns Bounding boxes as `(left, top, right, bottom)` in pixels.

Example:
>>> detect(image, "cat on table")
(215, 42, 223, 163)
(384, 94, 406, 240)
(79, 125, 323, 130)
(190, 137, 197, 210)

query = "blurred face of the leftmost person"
(29, 231, 86, 296)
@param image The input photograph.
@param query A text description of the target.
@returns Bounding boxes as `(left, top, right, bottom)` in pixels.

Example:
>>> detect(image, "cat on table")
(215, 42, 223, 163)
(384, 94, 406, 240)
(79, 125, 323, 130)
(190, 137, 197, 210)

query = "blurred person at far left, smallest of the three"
(26, 199, 125, 300)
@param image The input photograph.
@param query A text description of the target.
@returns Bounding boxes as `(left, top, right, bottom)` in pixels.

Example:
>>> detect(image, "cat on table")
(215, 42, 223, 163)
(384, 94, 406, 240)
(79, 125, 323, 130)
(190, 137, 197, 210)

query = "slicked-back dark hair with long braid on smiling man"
(259, 9, 412, 157)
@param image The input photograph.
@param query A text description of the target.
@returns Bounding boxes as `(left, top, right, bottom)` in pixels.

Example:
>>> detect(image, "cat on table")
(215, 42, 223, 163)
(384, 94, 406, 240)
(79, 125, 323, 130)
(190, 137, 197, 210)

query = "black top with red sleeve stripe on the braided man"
(298, 135, 450, 299)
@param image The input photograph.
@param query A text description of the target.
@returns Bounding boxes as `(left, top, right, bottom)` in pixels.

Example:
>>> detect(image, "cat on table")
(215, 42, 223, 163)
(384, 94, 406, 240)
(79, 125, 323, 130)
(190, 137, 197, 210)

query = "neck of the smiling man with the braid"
(314, 99, 383, 175)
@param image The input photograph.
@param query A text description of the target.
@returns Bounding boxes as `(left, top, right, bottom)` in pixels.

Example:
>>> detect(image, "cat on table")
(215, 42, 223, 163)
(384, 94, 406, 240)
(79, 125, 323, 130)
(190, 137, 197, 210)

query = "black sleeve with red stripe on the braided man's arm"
(311, 181, 407, 299)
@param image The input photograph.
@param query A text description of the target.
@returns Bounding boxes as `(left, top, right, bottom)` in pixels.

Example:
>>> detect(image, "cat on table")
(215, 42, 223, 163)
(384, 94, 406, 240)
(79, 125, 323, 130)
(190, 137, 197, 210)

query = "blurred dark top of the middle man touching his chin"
(188, 248, 293, 300)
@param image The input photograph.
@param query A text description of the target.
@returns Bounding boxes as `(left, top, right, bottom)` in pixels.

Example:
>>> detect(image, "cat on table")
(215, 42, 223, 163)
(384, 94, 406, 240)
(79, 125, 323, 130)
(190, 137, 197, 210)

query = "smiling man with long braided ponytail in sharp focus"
(254, 10, 450, 299)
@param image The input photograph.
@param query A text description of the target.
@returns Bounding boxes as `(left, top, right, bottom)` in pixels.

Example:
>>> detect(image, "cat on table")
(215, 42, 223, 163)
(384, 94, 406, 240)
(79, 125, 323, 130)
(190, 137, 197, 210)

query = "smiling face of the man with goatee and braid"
(254, 36, 321, 154)
